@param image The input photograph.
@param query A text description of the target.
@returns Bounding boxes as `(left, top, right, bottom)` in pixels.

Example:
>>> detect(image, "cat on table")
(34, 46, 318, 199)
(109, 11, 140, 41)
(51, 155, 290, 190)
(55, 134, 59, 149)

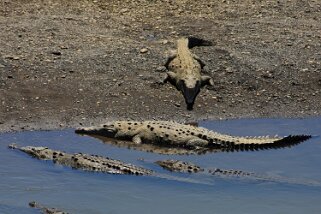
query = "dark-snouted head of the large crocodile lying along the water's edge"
(75, 124, 118, 138)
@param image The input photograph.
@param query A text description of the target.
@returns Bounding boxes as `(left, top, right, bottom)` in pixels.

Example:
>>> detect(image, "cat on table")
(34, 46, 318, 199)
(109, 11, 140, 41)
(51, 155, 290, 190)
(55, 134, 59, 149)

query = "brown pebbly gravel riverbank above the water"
(0, 0, 321, 131)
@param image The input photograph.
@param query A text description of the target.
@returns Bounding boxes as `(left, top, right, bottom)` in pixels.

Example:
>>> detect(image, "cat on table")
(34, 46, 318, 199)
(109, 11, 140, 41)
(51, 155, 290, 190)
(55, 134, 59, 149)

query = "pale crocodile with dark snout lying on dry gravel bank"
(164, 37, 214, 110)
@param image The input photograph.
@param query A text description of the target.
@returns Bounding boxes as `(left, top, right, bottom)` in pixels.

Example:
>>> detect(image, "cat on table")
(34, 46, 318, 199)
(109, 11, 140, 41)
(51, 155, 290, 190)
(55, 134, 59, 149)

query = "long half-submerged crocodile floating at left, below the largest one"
(9, 144, 152, 175)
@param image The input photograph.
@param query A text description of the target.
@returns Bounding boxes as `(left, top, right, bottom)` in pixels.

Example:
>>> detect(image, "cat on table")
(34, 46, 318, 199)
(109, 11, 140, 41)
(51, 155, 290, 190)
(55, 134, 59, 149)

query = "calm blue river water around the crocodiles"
(0, 118, 321, 214)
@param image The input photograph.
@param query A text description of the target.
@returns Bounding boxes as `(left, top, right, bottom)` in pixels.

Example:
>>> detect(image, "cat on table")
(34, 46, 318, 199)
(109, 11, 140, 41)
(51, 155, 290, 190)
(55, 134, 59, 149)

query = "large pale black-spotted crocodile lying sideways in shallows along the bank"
(75, 121, 311, 151)
